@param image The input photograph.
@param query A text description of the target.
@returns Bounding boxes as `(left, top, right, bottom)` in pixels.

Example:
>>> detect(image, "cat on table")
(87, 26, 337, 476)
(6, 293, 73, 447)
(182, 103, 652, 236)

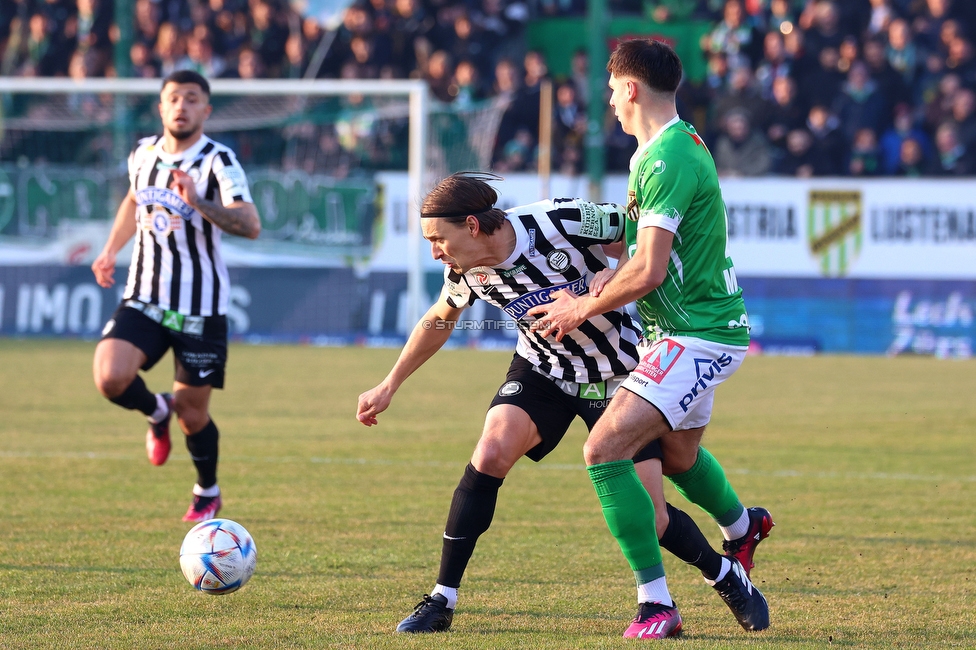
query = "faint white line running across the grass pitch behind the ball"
(0, 450, 976, 483)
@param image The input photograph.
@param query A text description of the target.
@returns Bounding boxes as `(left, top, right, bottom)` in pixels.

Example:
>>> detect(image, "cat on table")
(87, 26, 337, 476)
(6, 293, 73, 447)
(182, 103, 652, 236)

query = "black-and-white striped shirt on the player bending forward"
(442, 199, 640, 383)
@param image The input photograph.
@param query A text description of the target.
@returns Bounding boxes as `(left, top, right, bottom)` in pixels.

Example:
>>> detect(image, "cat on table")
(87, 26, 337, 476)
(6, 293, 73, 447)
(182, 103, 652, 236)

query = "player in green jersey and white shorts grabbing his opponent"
(529, 40, 773, 638)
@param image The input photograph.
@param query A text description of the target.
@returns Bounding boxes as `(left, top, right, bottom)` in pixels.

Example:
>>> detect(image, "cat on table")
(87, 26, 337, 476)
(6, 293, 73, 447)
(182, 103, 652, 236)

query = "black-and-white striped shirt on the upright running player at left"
(123, 136, 252, 316)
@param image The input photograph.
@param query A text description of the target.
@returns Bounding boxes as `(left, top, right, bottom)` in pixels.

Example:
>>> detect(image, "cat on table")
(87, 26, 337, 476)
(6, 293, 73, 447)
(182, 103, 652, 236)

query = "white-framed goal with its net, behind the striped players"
(0, 78, 503, 323)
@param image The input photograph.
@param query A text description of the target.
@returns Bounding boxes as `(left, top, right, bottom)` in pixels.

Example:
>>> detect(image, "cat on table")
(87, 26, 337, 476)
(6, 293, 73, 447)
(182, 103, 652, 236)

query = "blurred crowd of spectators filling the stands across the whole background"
(0, 0, 976, 176)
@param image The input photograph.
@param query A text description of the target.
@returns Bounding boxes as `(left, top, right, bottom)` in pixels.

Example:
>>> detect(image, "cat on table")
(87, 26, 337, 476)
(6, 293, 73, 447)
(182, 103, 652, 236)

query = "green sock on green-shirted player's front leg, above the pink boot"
(586, 460, 664, 585)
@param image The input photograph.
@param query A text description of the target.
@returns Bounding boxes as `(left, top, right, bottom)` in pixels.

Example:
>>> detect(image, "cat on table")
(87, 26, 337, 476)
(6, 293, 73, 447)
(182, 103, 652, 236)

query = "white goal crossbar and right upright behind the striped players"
(0, 77, 431, 327)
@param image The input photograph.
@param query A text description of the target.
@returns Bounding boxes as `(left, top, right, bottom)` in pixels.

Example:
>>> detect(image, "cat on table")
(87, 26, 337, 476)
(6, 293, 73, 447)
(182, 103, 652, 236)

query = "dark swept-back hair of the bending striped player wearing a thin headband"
(420, 172, 505, 235)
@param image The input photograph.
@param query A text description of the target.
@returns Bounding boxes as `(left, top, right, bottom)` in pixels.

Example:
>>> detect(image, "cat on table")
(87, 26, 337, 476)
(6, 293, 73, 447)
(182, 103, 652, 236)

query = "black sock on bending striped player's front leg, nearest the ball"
(437, 463, 505, 589)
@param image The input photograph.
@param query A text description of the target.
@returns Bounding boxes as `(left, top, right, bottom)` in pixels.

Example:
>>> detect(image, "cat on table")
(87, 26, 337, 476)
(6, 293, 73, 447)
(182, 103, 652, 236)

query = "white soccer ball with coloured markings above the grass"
(180, 519, 258, 596)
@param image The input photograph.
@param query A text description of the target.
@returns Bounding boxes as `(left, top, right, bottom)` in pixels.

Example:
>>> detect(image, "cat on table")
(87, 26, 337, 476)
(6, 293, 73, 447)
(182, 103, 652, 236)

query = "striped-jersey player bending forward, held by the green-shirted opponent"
(356, 173, 740, 633)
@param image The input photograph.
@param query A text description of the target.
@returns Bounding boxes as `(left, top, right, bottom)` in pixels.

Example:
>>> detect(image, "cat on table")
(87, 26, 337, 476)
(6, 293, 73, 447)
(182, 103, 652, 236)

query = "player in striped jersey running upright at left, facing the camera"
(92, 70, 261, 521)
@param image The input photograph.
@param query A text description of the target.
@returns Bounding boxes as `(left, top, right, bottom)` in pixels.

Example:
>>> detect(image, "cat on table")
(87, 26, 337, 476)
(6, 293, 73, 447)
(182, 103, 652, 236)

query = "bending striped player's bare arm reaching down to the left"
(356, 298, 464, 427)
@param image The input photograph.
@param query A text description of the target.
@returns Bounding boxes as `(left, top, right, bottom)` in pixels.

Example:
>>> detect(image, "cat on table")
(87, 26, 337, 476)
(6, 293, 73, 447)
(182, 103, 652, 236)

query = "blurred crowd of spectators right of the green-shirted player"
(684, 0, 976, 176)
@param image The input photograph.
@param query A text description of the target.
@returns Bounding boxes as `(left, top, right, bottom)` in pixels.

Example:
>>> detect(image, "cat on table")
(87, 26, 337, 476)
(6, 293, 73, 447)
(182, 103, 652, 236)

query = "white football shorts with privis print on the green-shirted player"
(621, 336, 748, 431)
